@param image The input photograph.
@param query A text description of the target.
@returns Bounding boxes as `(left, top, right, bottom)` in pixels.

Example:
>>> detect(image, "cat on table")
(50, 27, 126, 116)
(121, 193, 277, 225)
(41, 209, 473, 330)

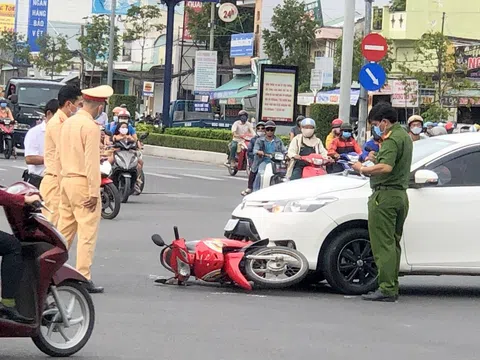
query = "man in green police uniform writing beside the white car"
(353, 103, 413, 302)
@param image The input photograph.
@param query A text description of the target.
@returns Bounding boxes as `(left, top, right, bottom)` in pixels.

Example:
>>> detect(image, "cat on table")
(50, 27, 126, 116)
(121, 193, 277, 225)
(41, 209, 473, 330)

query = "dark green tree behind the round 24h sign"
(186, 0, 254, 62)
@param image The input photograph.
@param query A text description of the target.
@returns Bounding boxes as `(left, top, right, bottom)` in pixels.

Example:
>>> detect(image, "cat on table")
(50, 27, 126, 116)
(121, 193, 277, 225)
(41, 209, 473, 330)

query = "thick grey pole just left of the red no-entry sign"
(339, 0, 355, 122)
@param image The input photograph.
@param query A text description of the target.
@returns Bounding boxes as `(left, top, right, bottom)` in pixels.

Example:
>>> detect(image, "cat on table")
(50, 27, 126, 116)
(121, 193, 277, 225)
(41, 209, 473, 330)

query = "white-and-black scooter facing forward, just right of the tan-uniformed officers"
(110, 133, 148, 203)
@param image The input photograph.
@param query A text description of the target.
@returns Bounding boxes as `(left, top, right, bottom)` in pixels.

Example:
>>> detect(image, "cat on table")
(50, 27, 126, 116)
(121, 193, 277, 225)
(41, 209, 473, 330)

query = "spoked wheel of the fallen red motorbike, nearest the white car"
(245, 246, 309, 289)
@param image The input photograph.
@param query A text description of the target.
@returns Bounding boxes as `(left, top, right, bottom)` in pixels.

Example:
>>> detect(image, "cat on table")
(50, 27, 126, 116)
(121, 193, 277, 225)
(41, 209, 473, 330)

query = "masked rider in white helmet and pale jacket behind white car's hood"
(287, 118, 328, 180)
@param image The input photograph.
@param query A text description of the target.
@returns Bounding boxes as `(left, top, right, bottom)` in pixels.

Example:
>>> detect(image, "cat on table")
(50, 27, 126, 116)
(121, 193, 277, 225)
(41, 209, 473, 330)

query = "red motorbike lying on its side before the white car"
(152, 227, 308, 290)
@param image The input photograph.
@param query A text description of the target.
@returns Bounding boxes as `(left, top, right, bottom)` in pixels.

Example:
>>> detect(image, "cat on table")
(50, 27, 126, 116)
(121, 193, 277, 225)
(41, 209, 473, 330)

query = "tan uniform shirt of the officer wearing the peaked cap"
(59, 110, 101, 198)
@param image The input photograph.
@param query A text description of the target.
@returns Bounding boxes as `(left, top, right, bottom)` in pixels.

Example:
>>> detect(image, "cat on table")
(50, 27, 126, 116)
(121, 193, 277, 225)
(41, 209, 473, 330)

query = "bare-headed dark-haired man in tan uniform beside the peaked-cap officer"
(40, 85, 82, 226)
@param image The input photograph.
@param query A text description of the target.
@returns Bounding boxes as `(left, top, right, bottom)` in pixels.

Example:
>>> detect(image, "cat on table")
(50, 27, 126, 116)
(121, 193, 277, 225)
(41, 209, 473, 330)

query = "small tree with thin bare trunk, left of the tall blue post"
(123, 5, 165, 98)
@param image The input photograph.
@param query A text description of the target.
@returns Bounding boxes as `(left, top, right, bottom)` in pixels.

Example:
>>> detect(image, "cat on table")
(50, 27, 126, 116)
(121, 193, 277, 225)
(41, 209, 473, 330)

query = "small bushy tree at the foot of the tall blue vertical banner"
(34, 34, 72, 79)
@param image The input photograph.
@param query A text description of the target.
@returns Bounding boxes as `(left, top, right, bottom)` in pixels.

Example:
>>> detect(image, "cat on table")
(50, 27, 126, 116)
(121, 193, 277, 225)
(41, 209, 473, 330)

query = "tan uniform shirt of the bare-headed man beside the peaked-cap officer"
(43, 109, 67, 177)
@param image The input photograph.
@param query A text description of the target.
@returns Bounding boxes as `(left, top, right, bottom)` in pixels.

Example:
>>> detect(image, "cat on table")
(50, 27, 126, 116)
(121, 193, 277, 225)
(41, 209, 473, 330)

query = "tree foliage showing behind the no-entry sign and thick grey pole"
(333, 34, 394, 83)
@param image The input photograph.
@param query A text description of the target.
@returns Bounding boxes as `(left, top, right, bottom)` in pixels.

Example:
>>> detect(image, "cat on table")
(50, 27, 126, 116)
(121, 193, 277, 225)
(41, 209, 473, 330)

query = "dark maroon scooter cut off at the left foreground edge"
(0, 182, 95, 357)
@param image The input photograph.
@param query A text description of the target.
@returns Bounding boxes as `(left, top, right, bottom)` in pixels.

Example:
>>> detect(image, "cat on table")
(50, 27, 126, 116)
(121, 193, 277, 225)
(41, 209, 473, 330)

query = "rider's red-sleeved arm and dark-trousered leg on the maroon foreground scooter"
(0, 190, 41, 324)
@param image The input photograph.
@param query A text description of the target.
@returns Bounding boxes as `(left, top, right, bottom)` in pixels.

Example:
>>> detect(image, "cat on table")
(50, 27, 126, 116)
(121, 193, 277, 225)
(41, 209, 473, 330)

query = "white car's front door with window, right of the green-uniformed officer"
(405, 146, 480, 271)
